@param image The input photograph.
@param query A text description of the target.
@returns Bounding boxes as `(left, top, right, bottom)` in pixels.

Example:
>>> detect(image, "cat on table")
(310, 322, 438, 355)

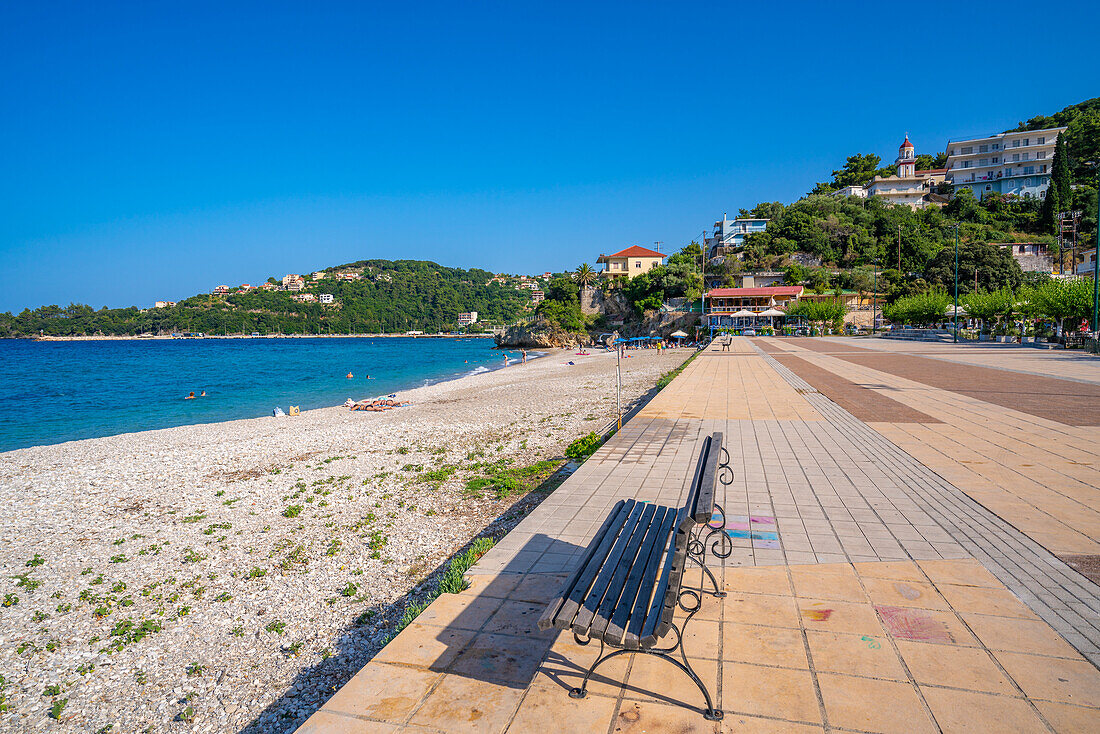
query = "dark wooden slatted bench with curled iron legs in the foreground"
(538, 432, 733, 721)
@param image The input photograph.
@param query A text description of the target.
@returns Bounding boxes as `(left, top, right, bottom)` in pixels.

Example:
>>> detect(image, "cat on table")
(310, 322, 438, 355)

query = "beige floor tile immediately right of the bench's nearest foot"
(722, 662, 821, 723)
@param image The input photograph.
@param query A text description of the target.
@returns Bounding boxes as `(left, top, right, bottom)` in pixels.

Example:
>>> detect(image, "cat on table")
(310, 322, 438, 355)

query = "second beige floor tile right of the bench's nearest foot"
(817, 672, 936, 734)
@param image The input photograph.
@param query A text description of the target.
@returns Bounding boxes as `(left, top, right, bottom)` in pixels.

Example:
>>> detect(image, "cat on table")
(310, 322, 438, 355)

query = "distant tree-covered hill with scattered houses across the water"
(0, 260, 541, 337)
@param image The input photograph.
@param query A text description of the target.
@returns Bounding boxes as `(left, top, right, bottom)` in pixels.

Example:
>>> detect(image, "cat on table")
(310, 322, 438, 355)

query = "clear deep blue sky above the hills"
(0, 1, 1100, 311)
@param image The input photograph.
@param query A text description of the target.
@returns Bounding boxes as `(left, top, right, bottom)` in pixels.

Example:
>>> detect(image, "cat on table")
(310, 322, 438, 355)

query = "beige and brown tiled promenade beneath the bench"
(301, 339, 1100, 733)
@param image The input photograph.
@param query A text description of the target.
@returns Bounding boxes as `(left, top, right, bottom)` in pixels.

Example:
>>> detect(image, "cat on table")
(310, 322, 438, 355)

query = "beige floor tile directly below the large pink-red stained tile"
(897, 639, 1019, 695)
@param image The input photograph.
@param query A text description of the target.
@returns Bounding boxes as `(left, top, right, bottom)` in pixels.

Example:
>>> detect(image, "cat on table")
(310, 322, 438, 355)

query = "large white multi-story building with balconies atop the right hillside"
(947, 128, 1065, 199)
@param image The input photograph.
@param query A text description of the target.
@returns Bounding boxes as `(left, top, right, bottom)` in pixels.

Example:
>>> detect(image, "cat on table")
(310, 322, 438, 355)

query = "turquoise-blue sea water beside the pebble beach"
(0, 338, 518, 451)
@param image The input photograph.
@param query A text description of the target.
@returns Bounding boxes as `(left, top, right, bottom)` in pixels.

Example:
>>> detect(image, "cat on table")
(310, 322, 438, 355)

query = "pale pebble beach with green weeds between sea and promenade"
(0, 350, 691, 732)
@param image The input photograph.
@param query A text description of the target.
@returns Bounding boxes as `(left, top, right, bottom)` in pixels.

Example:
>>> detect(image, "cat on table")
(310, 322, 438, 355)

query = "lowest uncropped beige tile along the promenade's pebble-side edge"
(325, 662, 440, 723)
